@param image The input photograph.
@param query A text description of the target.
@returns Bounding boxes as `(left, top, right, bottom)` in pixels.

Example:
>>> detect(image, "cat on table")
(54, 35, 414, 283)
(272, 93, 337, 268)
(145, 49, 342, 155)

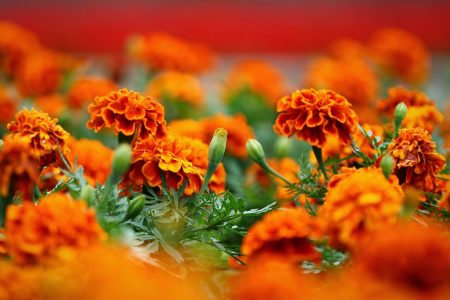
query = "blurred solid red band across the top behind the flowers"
(0, 0, 450, 53)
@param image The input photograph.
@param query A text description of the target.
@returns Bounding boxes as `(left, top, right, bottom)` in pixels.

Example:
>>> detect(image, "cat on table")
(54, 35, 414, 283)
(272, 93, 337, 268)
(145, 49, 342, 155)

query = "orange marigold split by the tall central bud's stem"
(180, 136, 227, 194)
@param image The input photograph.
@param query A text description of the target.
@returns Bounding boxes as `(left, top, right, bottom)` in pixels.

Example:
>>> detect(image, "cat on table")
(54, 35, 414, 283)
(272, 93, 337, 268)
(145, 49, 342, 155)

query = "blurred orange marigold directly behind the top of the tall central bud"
(202, 114, 254, 158)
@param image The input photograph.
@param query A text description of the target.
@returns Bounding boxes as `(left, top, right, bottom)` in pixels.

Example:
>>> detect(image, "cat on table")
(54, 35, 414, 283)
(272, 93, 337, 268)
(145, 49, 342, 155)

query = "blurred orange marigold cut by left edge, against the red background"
(0, 21, 40, 75)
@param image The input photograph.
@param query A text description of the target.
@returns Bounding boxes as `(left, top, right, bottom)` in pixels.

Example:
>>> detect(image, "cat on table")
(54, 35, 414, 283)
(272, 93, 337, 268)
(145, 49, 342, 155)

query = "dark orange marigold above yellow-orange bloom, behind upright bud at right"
(378, 86, 435, 117)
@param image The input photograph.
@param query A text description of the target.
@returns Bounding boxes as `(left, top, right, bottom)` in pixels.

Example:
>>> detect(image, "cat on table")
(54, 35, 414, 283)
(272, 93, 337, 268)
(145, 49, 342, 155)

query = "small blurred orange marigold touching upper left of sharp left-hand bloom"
(67, 77, 118, 109)
